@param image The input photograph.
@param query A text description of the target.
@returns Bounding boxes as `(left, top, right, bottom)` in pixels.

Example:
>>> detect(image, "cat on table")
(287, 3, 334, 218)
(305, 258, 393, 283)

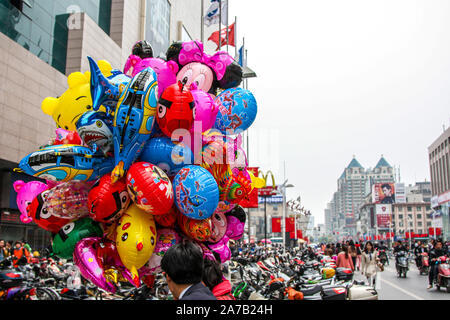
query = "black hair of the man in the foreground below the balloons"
(161, 240, 203, 284)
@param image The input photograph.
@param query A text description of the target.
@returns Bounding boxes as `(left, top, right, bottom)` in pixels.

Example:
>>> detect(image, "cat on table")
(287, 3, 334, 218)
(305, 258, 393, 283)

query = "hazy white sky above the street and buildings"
(221, 0, 450, 223)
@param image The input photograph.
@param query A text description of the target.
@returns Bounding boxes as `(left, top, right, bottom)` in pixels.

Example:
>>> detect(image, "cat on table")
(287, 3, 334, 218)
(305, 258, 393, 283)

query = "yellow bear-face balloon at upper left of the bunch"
(41, 60, 112, 131)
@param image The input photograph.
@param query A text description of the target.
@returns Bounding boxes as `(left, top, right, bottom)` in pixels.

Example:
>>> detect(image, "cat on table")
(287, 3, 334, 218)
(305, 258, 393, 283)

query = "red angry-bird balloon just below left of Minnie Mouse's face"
(156, 82, 195, 137)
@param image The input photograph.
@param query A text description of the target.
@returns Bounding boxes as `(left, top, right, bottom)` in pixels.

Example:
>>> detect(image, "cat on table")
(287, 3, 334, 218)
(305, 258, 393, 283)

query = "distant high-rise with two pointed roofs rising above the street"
(326, 155, 395, 237)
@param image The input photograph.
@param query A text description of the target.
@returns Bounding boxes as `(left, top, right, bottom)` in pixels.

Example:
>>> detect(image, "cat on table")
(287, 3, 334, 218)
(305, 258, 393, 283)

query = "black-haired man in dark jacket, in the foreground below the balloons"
(161, 241, 217, 300)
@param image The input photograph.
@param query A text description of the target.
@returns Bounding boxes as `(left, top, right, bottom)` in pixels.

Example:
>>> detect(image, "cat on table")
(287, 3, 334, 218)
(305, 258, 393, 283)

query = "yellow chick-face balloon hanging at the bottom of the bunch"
(116, 204, 157, 286)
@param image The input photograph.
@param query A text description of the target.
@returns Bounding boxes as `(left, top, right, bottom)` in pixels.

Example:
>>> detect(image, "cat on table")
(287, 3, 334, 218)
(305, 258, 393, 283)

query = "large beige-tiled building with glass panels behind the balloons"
(0, 0, 207, 248)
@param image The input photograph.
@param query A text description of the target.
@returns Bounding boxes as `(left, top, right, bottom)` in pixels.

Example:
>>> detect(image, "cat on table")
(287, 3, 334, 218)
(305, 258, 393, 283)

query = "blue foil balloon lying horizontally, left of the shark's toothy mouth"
(17, 145, 114, 182)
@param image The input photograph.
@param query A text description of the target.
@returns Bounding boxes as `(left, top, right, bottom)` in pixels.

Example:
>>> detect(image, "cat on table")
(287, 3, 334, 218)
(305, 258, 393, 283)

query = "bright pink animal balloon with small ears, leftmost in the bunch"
(13, 180, 49, 223)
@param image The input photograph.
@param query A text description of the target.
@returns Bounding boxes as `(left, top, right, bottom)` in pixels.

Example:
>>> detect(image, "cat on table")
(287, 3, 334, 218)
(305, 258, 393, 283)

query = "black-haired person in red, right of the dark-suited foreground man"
(202, 259, 236, 300)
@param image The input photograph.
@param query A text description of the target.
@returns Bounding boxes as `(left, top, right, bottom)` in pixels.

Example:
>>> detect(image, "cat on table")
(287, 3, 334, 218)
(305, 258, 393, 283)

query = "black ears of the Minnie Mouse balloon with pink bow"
(166, 41, 243, 95)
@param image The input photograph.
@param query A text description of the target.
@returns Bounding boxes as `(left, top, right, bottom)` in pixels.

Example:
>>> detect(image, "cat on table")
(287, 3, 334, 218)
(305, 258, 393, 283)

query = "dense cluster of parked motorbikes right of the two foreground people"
(229, 249, 378, 300)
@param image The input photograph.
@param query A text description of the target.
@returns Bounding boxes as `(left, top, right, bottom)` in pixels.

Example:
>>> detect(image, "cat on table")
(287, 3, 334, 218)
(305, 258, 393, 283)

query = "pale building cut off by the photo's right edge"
(428, 127, 450, 240)
